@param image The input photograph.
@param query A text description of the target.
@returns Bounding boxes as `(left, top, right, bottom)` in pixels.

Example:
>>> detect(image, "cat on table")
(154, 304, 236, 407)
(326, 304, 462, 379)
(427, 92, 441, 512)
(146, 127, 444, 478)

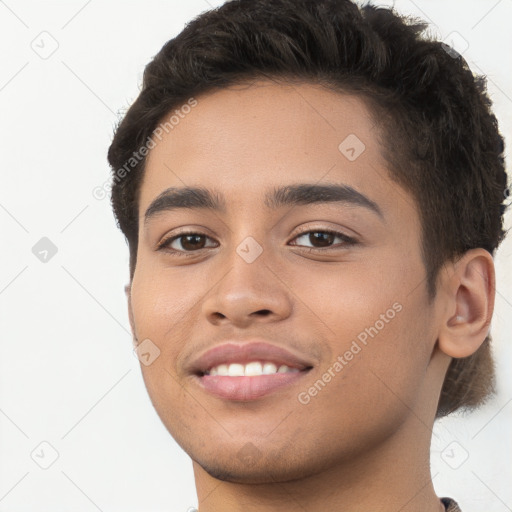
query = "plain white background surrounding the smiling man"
(0, 0, 512, 512)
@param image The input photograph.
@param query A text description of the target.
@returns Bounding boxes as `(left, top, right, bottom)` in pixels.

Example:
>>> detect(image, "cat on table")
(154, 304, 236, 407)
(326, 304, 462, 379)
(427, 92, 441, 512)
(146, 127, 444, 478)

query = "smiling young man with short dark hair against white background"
(108, 0, 507, 512)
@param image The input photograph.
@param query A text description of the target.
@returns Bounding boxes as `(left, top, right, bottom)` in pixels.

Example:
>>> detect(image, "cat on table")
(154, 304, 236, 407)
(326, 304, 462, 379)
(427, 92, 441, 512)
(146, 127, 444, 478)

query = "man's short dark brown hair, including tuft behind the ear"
(108, 0, 507, 417)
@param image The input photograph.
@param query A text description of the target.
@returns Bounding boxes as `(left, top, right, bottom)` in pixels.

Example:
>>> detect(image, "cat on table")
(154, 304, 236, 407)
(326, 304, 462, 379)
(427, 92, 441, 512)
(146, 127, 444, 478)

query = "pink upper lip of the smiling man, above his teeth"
(189, 340, 312, 374)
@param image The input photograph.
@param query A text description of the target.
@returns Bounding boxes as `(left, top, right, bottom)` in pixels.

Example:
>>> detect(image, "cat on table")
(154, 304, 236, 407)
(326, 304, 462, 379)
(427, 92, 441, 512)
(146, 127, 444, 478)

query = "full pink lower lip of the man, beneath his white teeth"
(197, 370, 308, 401)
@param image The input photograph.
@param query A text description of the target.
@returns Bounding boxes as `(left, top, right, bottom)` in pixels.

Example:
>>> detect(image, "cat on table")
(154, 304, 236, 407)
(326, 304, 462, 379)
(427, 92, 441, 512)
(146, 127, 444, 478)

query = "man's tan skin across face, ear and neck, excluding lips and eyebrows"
(127, 81, 494, 512)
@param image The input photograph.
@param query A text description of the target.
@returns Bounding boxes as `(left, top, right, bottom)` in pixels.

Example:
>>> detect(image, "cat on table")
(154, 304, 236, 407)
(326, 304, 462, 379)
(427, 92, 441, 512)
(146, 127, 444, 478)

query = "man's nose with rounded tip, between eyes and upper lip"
(202, 241, 293, 327)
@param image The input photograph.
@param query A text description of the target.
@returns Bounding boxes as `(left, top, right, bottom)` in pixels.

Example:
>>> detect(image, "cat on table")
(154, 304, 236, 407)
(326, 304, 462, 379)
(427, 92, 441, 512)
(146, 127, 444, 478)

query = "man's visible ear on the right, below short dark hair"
(438, 248, 496, 358)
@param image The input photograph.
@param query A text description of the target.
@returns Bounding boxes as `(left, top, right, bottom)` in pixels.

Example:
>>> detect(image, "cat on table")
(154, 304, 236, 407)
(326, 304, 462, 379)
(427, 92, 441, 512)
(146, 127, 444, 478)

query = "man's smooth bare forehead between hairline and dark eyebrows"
(139, 81, 411, 216)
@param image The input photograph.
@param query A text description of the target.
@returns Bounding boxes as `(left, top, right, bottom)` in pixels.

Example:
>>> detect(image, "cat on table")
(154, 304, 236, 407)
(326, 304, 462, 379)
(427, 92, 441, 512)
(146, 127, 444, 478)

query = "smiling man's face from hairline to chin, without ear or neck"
(131, 82, 444, 482)
